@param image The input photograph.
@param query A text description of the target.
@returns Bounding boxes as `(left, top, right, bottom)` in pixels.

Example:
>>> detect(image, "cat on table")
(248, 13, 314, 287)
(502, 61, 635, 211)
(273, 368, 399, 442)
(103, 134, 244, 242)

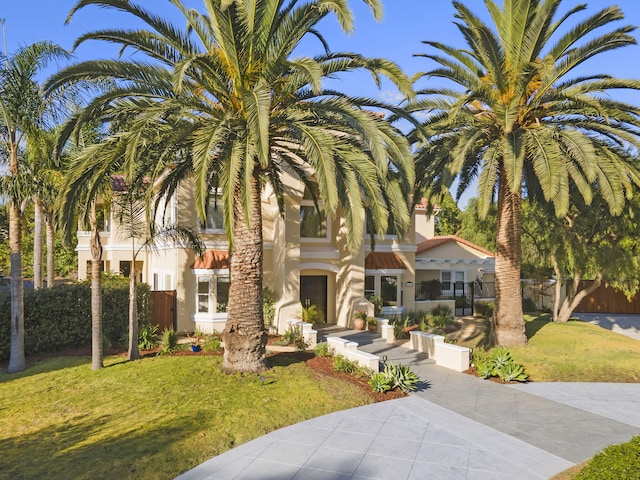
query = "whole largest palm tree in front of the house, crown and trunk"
(48, 0, 414, 371)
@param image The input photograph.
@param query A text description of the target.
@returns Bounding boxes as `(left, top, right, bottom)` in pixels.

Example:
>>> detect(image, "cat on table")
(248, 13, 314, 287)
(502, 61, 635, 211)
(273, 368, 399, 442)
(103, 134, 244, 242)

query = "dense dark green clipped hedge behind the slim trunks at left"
(0, 277, 151, 361)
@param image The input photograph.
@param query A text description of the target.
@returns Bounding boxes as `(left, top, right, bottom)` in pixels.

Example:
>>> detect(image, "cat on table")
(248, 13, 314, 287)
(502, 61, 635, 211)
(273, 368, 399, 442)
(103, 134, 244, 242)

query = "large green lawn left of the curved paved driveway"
(0, 355, 371, 480)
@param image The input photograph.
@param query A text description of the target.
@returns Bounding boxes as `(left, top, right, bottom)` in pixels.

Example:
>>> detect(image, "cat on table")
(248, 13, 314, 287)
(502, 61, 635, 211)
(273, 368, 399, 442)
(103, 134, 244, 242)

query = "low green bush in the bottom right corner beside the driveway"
(574, 436, 640, 480)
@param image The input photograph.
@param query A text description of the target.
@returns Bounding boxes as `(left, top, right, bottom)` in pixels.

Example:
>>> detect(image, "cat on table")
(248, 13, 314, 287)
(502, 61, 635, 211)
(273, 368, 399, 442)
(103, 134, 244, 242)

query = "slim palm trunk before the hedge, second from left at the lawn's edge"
(89, 201, 104, 370)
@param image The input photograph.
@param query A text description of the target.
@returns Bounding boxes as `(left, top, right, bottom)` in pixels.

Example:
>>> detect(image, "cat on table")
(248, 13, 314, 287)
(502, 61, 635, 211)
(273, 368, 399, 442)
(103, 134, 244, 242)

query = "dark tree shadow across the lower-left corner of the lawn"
(0, 411, 204, 480)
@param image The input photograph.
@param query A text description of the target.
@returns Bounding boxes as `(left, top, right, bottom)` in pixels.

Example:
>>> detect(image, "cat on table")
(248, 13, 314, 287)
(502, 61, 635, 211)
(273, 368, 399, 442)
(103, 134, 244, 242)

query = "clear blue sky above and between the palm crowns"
(0, 0, 640, 203)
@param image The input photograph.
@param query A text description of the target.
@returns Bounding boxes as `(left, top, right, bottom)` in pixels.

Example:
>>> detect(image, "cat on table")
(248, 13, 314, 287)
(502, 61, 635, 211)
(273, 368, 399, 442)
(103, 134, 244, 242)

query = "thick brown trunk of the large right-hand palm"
(492, 172, 527, 346)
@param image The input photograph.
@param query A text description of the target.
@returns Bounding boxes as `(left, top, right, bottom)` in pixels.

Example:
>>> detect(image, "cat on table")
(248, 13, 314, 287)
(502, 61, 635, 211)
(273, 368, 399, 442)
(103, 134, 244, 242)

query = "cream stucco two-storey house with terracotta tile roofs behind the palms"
(77, 175, 493, 332)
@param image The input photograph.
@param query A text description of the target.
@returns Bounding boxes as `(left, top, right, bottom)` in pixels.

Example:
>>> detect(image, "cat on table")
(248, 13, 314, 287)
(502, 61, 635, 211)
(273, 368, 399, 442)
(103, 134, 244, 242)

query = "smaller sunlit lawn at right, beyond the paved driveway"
(509, 315, 640, 383)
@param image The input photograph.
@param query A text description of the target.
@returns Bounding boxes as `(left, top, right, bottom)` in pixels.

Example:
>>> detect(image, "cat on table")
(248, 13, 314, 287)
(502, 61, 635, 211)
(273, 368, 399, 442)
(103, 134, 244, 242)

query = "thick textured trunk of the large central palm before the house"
(222, 176, 267, 373)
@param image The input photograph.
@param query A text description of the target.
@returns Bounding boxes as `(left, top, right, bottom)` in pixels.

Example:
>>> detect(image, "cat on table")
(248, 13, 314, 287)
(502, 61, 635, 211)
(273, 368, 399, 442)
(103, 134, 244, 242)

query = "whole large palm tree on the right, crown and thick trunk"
(412, 0, 640, 345)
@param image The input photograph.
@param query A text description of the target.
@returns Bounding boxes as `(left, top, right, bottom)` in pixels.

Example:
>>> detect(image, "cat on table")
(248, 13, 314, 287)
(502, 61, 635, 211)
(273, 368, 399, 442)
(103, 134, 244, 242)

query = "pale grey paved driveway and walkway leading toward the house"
(178, 331, 640, 480)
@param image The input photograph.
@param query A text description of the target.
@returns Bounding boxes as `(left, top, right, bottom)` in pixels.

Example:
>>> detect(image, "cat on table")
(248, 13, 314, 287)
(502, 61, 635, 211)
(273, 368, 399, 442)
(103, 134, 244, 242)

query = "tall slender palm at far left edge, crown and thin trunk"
(0, 42, 66, 372)
